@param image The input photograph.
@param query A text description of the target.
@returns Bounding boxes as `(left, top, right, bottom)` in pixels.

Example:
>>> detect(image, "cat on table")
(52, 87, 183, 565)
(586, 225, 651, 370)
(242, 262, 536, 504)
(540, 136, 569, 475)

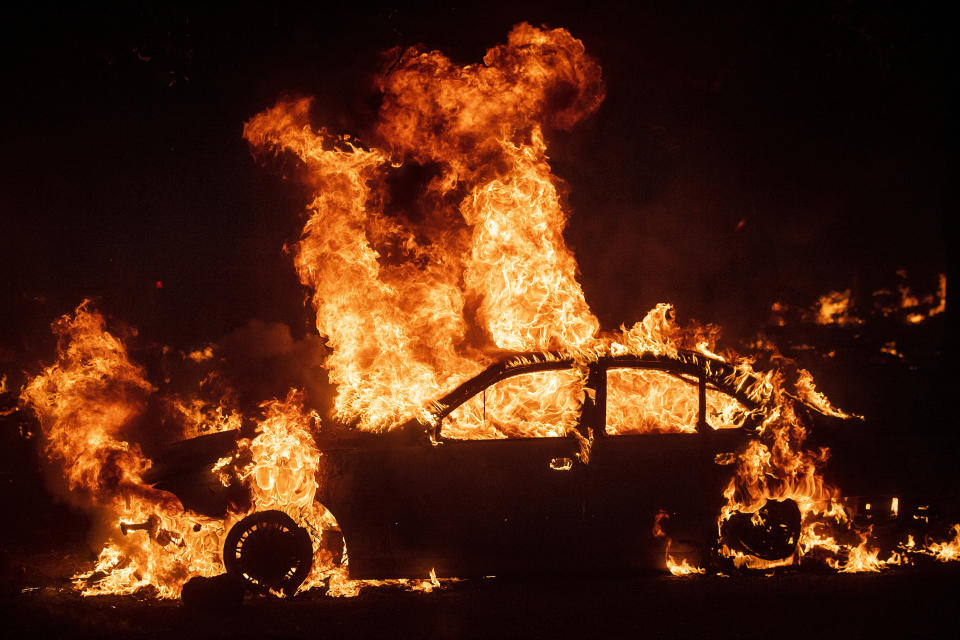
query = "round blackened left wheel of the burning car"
(223, 511, 313, 596)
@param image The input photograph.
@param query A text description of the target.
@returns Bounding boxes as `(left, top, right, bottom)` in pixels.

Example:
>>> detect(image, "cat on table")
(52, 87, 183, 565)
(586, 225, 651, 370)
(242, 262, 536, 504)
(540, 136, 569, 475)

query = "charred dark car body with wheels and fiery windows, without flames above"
(146, 351, 801, 592)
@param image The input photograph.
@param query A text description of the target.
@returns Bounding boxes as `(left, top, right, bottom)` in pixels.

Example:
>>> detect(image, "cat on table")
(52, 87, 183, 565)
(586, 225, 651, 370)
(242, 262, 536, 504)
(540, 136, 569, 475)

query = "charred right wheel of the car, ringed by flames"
(720, 500, 801, 560)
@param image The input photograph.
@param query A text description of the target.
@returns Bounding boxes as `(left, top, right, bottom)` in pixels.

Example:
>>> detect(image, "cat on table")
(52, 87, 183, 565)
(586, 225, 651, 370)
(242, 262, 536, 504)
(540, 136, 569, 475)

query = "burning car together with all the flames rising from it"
(21, 23, 956, 597)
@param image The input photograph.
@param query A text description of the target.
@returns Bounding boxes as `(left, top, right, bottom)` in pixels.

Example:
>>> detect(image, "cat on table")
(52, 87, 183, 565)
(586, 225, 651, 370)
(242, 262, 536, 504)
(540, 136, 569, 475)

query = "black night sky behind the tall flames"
(0, 1, 955, 384)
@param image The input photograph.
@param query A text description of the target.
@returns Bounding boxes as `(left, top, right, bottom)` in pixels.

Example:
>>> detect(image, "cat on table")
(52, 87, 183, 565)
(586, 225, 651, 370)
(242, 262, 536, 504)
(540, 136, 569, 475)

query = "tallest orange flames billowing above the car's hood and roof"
(244, 24, 603, 430)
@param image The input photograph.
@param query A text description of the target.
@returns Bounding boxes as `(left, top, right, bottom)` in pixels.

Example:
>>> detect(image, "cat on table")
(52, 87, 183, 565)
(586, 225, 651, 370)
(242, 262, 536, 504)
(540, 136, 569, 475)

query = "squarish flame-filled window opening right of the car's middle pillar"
(606, 368, 699, 435)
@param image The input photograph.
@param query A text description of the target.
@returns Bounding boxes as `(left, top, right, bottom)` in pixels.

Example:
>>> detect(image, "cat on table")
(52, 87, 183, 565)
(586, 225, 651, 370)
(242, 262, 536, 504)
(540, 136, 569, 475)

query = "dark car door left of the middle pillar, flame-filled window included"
(412, 368, 585, 575)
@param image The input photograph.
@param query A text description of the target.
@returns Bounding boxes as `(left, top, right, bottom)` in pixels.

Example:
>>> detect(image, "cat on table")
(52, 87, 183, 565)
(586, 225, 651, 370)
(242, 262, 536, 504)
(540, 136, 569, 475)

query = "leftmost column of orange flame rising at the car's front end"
(22, 302, 224, 597)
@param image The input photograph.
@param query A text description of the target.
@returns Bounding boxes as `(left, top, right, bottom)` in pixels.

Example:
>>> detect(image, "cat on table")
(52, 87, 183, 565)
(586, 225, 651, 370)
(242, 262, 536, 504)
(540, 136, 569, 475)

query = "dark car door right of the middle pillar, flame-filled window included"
(587, 365, 735, 569)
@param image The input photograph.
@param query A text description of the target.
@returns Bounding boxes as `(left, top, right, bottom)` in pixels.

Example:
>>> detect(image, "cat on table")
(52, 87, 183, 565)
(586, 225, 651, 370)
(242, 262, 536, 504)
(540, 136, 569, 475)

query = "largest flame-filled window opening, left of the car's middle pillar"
(440, 369, 586, 440)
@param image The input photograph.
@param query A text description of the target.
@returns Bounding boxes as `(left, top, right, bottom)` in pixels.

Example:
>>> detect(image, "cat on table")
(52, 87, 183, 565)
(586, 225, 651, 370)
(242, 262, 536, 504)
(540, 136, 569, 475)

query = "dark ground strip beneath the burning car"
(0, 550, 960, 639)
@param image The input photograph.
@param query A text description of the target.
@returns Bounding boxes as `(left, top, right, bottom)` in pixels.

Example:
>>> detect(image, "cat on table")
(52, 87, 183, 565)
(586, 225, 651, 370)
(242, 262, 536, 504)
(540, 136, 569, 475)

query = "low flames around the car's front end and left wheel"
(21, 301, 460, 598)
